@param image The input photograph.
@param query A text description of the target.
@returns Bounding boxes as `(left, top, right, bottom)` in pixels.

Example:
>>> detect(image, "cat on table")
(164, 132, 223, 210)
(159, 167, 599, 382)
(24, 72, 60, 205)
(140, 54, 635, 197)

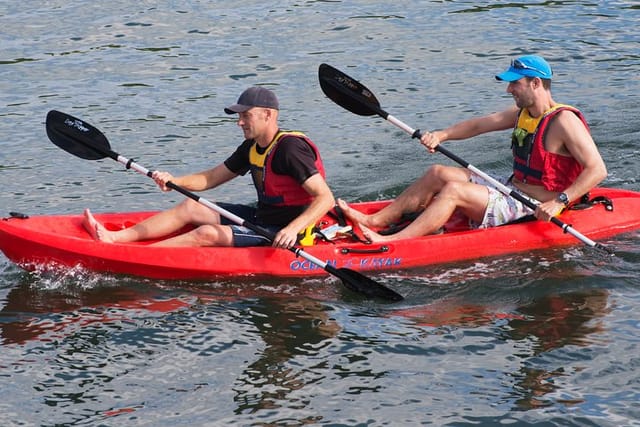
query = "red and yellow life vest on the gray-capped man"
(249, 131, 325, 206)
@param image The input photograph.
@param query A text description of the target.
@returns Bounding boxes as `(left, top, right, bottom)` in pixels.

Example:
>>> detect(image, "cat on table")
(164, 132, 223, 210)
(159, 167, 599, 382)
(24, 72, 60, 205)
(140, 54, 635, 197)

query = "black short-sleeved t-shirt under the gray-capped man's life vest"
(224, 136, 319, 226)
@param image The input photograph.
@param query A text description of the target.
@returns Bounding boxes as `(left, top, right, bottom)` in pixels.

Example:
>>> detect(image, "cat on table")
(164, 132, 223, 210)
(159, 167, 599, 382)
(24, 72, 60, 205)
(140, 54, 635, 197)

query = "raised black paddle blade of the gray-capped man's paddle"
(46, 110, 111, 160)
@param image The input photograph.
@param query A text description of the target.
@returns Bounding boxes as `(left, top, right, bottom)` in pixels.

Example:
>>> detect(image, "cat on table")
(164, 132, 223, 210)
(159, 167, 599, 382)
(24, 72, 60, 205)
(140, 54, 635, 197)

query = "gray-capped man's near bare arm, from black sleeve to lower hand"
(273, 173, 335, 248)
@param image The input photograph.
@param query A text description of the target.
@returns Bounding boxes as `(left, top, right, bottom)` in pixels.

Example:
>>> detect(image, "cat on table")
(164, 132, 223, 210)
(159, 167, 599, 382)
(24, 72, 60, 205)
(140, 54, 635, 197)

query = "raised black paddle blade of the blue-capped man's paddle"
(318, 64, 385, 117)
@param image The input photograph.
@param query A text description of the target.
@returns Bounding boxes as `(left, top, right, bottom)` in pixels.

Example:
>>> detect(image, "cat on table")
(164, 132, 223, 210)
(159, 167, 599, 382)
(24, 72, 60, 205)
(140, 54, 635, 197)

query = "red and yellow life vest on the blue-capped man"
(511, 104, 589, 192)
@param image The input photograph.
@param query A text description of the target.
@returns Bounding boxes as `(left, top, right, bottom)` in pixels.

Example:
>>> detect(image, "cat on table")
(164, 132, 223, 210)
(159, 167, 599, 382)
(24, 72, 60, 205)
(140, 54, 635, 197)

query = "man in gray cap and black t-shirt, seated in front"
(84, 87, 334, 248)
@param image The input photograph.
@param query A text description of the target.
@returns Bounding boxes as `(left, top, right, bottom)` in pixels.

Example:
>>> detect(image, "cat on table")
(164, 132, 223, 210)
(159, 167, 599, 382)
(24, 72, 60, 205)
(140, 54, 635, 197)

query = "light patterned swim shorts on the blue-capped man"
(470, 174, 537, 228)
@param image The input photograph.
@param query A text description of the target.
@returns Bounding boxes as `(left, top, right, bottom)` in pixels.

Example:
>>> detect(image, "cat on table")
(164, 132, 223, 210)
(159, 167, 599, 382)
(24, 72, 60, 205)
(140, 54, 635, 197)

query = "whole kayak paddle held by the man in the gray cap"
(46, 110, 403, 301)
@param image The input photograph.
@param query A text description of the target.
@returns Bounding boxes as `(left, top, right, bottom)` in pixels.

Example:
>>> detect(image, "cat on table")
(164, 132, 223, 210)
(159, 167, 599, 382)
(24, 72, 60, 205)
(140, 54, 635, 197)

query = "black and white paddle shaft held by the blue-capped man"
(372, 107, 613, 253)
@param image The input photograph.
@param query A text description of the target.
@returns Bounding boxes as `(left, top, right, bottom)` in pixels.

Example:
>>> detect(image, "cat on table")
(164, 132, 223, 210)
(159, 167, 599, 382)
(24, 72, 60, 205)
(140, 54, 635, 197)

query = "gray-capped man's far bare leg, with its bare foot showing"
(83, 199, 220, 243)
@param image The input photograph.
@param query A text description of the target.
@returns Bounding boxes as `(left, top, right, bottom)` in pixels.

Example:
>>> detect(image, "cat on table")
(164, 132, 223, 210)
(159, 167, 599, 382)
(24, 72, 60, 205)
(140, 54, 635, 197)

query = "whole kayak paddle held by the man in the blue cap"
(318, 64, 613, 254)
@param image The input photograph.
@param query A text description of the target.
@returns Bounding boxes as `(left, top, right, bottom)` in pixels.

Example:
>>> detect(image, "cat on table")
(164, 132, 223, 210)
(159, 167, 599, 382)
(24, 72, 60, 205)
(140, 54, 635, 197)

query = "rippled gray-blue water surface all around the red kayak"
(0, 0, 640, 426)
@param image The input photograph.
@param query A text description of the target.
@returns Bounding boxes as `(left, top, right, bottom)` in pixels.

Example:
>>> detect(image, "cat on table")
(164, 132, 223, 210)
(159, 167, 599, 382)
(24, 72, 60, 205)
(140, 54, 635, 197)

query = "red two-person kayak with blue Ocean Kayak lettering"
(0, 188, 640, 279)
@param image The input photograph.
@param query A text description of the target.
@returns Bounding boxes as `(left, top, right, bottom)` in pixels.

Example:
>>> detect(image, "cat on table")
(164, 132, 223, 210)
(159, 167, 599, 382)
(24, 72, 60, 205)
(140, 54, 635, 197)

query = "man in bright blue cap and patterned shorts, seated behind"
(338, 55, 607, 241)
